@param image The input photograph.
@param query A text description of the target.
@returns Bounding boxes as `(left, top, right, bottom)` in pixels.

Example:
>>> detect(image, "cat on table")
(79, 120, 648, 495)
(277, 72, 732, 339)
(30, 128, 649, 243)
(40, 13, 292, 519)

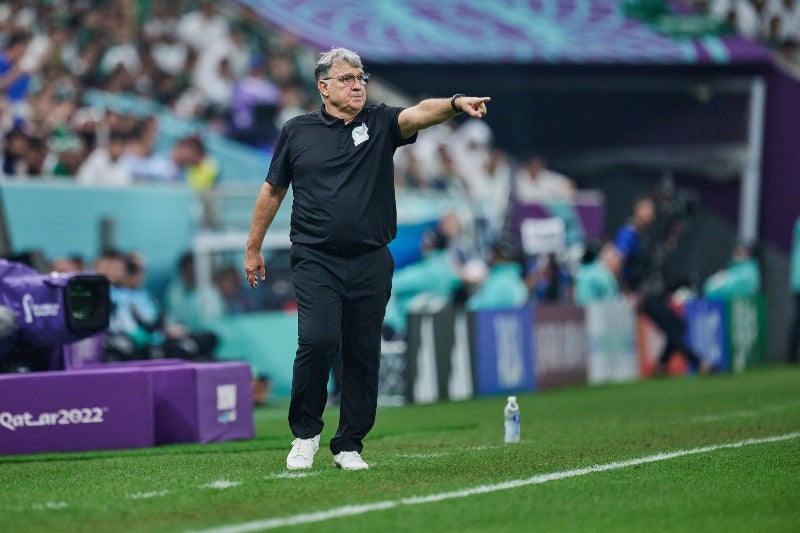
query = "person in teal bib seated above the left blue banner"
(467, 239, 529, 311)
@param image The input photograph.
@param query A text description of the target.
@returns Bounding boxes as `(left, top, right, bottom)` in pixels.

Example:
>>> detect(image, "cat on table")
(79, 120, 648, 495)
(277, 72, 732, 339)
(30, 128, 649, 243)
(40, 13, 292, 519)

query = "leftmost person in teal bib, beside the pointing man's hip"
(384, 229, 462, 338)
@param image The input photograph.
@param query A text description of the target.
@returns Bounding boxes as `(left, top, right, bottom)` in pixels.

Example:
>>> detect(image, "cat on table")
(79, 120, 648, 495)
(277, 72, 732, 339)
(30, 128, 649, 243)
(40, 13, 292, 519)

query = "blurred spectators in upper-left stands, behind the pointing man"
(0, 0, 317, 184)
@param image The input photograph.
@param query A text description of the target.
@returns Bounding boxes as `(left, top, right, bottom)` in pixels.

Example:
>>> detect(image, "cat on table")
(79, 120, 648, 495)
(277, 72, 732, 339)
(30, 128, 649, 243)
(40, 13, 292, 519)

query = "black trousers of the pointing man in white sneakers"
(289, 244, 394, 454)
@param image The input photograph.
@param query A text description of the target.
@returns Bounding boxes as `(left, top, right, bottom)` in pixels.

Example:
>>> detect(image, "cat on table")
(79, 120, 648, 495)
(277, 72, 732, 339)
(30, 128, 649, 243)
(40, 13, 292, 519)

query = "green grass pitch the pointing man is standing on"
(0, 367, 800, 533)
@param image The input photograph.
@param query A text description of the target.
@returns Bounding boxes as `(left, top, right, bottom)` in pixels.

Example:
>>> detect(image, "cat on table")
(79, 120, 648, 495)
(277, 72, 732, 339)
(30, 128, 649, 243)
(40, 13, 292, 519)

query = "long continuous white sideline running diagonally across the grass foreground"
(192, 431, 800, 533)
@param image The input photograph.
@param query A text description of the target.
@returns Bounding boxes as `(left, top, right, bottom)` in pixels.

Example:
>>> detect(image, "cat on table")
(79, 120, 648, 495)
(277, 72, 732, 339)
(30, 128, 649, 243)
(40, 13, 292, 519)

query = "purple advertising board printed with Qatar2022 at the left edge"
(0, 368, 155, 454)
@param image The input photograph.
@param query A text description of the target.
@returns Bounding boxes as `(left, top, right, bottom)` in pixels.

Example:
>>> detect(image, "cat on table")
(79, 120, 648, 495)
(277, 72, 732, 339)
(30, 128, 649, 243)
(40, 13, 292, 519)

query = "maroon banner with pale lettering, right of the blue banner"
(533, 304, 589, 389)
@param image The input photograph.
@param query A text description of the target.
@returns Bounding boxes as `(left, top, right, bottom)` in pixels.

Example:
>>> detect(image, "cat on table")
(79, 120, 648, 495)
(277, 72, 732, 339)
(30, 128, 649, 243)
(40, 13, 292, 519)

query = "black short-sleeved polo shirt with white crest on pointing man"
(266, 104, 417, 254)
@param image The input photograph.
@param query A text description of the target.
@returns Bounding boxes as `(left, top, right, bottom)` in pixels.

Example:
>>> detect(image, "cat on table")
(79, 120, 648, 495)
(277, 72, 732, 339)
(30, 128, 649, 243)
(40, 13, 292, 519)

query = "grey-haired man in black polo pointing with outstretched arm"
(244, 48, 489, 470)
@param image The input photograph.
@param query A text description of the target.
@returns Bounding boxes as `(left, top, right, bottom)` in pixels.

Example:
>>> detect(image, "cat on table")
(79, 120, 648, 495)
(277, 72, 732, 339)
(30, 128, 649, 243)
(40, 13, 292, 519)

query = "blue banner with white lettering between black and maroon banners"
(470, 306, 536, 395)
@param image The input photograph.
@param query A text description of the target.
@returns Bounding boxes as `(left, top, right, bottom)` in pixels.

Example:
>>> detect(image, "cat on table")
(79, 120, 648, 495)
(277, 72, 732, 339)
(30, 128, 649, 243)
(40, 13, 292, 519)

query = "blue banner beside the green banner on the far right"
(683, 298, 730, 372)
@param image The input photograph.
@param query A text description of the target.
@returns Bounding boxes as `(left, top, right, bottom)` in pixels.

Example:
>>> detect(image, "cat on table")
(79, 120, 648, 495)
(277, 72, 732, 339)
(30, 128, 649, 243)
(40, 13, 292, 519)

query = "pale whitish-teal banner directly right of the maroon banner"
(585, 300, 639, 383)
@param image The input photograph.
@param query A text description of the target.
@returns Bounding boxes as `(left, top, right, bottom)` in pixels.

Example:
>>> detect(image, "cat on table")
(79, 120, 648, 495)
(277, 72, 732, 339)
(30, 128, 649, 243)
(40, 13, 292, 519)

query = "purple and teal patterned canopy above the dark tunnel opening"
(241, 0, 769, 64)
